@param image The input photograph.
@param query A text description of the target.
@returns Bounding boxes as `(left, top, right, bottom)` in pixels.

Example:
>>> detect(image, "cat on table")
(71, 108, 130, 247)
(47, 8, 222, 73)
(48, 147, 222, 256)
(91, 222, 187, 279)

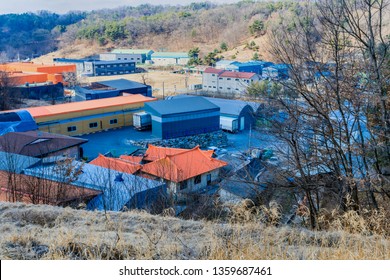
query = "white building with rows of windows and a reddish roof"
(202, 67, 260, 94)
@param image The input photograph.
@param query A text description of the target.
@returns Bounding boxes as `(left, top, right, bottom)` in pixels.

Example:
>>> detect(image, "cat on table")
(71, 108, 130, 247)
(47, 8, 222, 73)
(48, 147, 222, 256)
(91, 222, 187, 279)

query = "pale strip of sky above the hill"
(0, 0, 239, 14)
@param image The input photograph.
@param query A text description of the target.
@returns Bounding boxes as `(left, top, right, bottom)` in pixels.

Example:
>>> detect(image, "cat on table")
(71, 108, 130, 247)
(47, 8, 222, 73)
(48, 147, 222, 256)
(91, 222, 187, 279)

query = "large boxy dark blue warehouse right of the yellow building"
(145, 96, 220, 139)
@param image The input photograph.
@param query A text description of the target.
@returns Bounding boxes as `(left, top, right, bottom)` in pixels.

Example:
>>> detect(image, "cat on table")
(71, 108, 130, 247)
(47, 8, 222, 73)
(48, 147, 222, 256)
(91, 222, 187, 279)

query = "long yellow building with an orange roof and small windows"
(26, 94, 156, 136)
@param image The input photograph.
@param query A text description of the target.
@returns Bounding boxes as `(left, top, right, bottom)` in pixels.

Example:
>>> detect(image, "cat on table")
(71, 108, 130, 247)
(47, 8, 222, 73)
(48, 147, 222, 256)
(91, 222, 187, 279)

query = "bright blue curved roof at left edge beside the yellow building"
(0, 110, 38, 135)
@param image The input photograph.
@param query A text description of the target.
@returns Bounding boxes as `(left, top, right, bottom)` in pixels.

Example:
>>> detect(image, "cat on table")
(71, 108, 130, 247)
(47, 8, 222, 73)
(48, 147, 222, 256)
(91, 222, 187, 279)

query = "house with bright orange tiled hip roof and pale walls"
(141, 146, 227, 192)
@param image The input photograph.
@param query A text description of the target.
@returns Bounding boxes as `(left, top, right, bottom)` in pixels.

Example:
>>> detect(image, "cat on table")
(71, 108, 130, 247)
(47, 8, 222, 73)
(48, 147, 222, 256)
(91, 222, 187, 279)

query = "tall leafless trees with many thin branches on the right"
(258, 0, 388, 227)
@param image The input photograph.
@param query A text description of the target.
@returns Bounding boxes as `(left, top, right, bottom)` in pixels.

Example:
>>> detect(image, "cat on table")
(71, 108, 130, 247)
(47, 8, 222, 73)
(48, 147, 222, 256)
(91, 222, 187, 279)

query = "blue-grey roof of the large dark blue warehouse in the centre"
(145, 96, 219, 116)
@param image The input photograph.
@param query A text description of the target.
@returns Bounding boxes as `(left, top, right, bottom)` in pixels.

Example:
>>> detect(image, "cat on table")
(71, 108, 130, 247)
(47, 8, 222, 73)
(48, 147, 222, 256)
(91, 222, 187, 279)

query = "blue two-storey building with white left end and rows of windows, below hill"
(83, 60, 135, 76)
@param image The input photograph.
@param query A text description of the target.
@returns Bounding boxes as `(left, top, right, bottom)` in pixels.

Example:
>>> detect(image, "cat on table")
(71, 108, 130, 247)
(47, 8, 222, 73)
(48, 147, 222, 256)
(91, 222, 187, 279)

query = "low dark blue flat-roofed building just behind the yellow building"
(77, 79, 152, 100)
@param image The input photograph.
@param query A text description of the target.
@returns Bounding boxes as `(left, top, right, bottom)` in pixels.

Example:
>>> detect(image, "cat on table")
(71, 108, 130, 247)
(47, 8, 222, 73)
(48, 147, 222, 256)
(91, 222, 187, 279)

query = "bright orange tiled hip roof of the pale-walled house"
(142, 147, 227, 183)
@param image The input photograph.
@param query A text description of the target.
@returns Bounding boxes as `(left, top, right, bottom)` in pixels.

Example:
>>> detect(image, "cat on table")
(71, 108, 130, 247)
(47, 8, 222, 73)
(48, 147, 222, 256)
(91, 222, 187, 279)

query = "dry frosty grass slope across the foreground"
(0, 203, 390, 260)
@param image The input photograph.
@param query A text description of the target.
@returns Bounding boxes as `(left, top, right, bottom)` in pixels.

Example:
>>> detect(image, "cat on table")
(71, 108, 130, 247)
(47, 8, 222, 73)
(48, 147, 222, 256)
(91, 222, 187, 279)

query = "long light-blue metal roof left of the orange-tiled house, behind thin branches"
(24, 161, 162, 211)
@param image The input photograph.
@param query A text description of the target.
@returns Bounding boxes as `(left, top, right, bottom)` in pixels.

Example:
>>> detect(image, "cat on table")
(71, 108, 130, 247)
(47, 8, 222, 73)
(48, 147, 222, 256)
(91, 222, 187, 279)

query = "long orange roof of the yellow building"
(26, 94, 156, 118)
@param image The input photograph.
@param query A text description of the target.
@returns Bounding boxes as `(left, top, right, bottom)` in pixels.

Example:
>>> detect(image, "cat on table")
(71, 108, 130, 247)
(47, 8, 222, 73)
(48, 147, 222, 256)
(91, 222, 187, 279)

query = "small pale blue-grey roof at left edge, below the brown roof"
(0, 151, 40, 174)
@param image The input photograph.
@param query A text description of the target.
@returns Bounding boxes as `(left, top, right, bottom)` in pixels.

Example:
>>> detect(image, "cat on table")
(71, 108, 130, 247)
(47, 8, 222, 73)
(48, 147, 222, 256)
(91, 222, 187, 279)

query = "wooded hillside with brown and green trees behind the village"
(0, 0, 300, 59)
